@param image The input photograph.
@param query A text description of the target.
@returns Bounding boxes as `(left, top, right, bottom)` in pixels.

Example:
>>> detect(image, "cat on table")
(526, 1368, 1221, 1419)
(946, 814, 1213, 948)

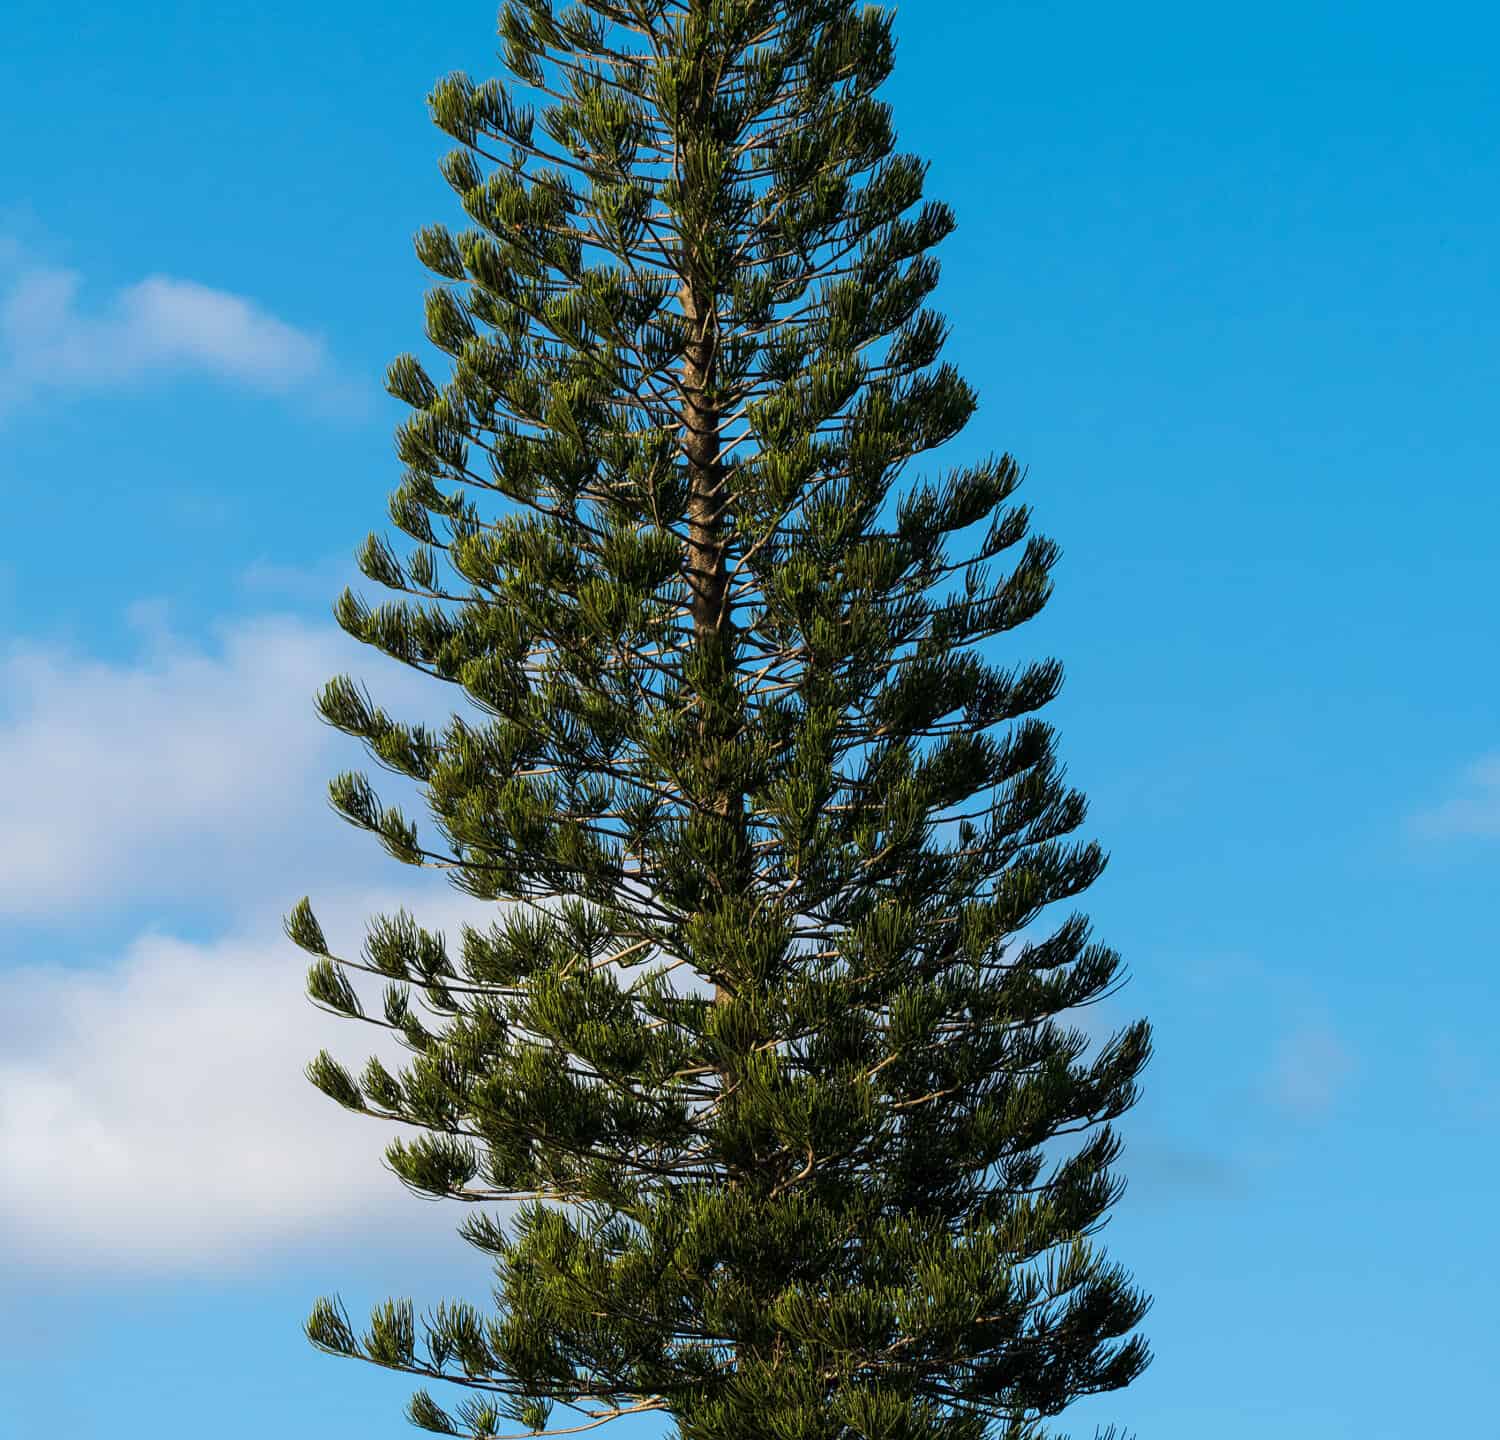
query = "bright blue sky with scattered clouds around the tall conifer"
(0, 0, 1500, 1440)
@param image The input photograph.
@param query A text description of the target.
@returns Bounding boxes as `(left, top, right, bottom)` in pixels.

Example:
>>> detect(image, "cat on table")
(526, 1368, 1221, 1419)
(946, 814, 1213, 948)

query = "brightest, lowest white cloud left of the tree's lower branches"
(0, 896, 501, 1269)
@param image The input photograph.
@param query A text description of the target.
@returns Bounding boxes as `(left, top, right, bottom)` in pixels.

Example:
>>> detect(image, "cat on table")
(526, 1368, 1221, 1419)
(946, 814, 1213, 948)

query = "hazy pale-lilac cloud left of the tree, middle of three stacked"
(0, 608, 348, 917)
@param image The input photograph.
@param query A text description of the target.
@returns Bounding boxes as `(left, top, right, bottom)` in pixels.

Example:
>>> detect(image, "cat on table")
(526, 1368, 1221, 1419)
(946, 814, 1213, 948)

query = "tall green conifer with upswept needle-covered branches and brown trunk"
(288, 0, 1149, 1440)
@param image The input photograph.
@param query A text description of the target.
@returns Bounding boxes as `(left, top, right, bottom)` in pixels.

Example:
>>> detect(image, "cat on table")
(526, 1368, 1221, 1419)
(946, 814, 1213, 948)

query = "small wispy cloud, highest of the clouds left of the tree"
(0, 246, 339, 410)
